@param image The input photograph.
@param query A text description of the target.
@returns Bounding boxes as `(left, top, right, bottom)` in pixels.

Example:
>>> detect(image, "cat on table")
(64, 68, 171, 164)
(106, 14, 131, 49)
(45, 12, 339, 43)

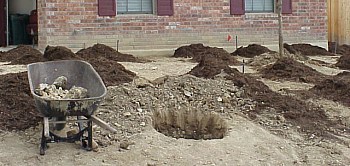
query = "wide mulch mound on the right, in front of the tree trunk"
(260, 57, 325, 83)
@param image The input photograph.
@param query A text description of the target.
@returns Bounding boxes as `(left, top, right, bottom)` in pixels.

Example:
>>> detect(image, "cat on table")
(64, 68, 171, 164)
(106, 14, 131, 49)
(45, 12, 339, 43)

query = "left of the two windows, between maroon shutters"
(117, 0, 153, 14)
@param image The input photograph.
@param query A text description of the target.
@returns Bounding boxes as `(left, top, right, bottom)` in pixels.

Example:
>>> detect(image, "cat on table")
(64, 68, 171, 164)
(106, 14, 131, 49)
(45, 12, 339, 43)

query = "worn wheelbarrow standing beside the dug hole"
(27, 60, 116, 155)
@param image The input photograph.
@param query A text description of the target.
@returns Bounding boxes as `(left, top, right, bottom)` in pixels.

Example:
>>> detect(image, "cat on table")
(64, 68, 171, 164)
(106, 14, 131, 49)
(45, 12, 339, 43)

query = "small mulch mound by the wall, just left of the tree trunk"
(231, 44, 275, 58)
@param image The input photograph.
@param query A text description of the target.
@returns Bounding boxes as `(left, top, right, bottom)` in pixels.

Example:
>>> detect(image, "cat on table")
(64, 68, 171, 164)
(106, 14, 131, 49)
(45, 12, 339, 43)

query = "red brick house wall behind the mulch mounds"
(38, 0, 327, 49)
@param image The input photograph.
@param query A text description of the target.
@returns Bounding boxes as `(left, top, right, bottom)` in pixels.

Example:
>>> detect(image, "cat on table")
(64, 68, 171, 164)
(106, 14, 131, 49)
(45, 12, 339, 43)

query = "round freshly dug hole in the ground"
(153, 110, 228, 140)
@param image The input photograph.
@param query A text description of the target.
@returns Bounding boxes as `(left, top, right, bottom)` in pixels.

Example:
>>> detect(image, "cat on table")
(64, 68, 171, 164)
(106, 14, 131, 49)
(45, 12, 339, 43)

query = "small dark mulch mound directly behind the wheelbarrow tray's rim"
(44, 46, 80, 61)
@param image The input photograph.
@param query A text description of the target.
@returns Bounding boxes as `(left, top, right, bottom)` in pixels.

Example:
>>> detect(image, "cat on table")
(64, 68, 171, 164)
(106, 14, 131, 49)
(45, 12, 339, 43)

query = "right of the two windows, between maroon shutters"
(245, 0, 274, 13)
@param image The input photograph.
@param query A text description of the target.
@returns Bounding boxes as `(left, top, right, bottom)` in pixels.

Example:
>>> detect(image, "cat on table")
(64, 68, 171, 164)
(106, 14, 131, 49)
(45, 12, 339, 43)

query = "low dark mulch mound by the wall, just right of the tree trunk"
(283, 43, 334, 56)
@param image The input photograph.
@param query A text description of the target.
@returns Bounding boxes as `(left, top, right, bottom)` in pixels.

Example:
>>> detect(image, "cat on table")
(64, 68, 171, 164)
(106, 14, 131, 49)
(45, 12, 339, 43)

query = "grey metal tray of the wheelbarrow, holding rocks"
(28, 60, 107, 117)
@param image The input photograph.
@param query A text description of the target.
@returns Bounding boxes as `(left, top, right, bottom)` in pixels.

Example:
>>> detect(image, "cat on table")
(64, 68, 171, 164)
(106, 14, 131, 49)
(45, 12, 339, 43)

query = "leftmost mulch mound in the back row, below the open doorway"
(0, 45, 45, 65)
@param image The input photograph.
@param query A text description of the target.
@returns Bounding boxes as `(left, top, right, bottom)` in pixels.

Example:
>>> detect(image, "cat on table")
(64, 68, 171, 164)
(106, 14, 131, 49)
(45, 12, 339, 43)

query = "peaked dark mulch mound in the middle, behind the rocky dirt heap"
(188, 57, 234, 78)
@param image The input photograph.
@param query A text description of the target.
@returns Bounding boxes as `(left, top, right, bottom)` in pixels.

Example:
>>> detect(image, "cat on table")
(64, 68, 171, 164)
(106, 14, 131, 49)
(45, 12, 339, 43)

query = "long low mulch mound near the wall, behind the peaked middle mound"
(173, 44, 239, 65)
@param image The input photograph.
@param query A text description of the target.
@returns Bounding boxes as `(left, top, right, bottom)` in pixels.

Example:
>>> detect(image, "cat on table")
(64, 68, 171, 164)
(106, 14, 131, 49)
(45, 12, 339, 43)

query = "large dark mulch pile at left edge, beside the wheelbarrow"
(0, 72, 41, 130)
